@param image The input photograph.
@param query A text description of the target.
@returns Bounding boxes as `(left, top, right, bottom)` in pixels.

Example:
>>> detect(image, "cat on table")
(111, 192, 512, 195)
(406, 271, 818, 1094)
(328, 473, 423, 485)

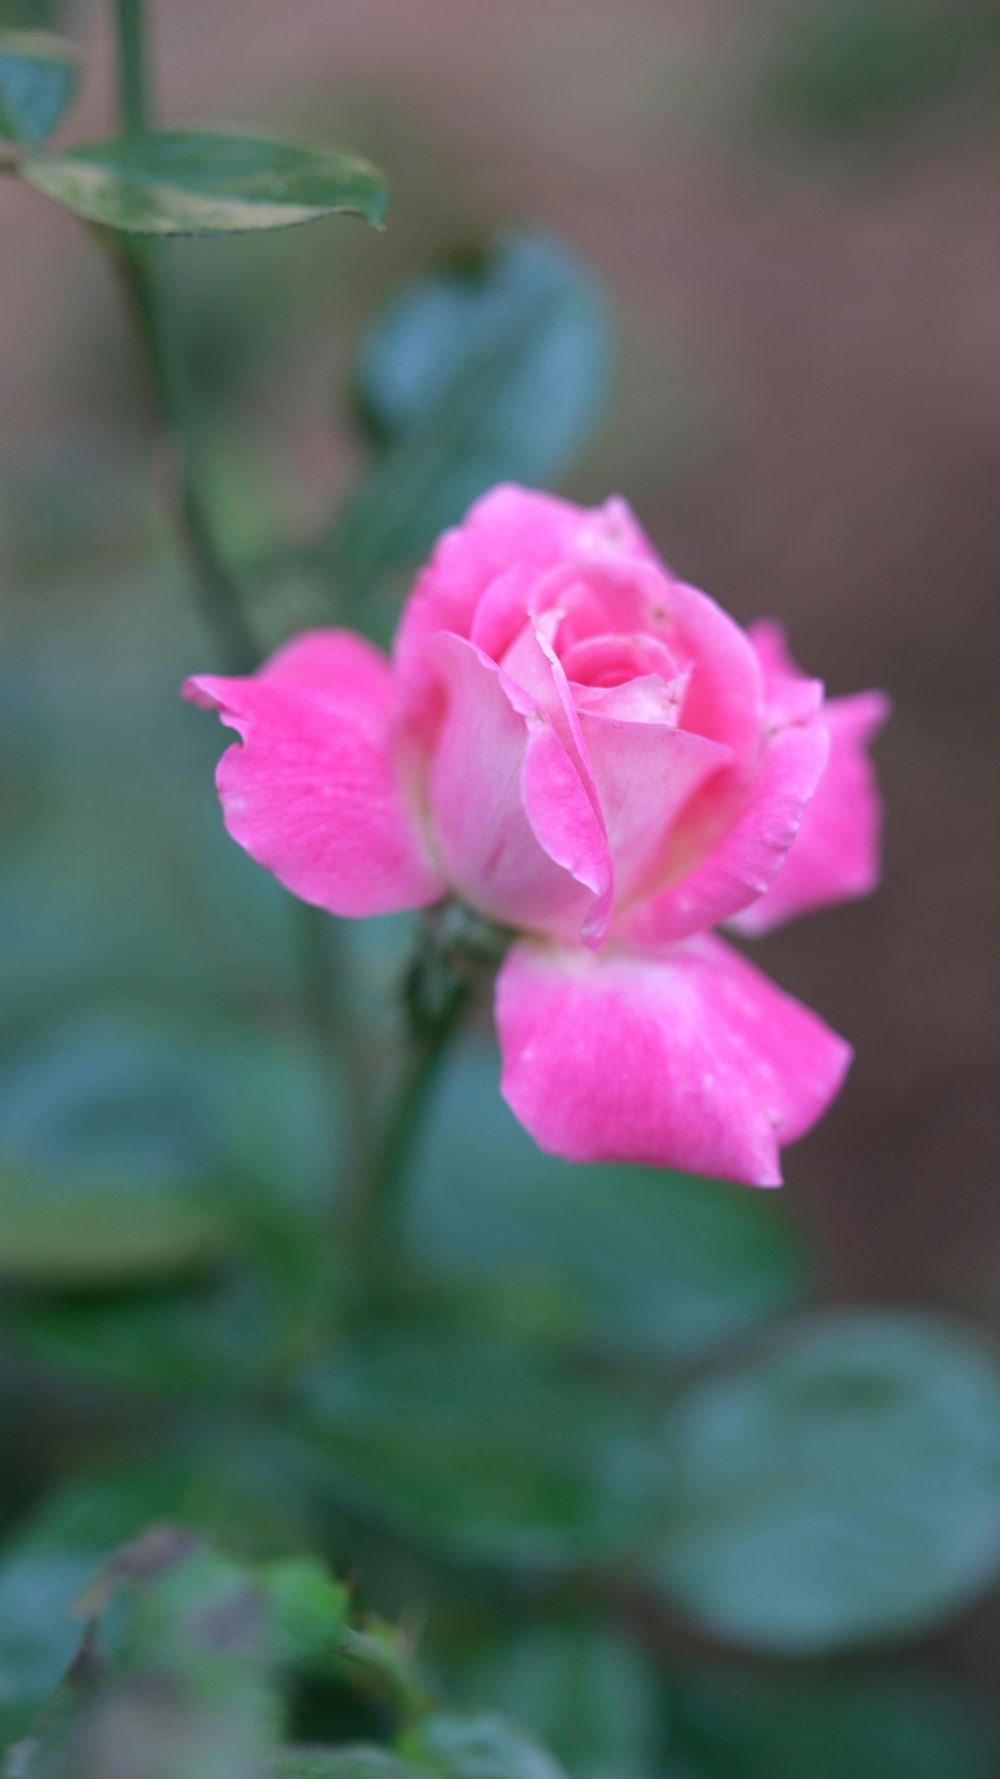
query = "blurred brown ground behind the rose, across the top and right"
(0, 0, 1000, 1658)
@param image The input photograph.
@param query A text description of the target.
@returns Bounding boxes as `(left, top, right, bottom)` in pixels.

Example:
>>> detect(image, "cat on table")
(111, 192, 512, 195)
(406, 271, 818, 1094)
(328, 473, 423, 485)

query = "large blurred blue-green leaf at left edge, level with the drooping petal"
(0, 1010, 341, 1280)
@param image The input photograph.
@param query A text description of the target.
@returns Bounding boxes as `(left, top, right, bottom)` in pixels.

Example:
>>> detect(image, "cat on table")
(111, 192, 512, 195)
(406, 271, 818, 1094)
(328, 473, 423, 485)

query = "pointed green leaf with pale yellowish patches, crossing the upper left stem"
(23, 128, 388, 235)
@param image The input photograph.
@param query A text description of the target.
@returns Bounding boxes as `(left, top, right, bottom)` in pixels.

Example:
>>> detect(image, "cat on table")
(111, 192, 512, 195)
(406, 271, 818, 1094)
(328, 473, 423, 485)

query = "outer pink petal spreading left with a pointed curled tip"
(183, 630, 445, 914)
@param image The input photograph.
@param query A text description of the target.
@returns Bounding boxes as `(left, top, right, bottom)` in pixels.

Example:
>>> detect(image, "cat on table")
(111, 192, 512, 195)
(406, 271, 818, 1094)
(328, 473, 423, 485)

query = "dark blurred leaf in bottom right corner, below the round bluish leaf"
(671, 1670, 1000, 1779)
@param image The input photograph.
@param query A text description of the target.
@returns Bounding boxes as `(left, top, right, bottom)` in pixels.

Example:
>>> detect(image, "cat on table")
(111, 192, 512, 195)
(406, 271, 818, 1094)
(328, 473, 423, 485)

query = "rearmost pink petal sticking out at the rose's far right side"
(733, 692, 890, 934)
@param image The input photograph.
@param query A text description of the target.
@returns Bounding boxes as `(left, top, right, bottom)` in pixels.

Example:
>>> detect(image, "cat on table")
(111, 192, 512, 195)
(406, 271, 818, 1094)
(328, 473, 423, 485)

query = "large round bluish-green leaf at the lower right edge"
(655, 1315, 1000, 1654)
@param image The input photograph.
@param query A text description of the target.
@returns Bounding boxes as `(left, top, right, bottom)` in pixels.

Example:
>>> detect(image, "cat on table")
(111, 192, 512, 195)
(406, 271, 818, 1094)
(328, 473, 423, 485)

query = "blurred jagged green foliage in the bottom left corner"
(4, 1522, 576, 1779)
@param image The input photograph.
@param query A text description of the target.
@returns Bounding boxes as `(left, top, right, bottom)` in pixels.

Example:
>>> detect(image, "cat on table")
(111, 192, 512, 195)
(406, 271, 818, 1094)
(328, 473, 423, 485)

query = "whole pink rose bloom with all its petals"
(185, 487, 886, 1187)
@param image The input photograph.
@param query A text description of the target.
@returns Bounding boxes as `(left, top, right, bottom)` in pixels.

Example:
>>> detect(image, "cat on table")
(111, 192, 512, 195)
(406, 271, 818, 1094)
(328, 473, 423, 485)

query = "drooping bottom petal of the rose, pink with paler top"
(496, 938, 851, 1187)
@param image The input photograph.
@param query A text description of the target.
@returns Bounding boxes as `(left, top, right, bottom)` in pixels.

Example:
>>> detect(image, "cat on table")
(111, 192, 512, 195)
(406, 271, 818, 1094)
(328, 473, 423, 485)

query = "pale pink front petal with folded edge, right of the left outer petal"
(431, 635, 612, 938)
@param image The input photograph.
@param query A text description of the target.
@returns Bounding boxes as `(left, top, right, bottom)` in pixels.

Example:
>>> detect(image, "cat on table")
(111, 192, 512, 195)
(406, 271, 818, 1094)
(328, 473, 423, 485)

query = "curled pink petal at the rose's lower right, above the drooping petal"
(619, 722, 829, 945)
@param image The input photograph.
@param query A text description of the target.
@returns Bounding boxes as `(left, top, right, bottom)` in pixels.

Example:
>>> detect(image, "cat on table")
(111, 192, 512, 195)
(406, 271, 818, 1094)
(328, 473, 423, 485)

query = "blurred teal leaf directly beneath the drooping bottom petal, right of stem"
(400, 1046, 811, 1361)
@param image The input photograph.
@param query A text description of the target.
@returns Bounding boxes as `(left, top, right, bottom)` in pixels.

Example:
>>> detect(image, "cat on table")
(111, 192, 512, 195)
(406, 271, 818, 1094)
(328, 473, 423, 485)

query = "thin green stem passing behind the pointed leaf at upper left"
(116, 0, 260, 672)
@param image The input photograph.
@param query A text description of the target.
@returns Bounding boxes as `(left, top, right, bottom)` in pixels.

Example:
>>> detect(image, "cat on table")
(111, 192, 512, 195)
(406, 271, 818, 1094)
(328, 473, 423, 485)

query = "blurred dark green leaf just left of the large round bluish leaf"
(304, 1325, 664, 1567)
